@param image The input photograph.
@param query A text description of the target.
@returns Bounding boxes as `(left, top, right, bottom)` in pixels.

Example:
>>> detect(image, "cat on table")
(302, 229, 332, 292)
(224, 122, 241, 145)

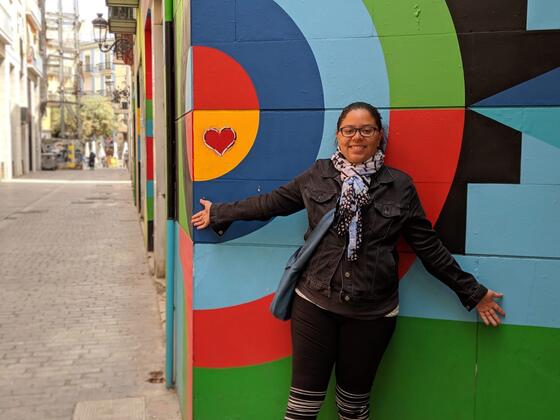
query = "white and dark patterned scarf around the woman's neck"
(331, 149, 385, 261)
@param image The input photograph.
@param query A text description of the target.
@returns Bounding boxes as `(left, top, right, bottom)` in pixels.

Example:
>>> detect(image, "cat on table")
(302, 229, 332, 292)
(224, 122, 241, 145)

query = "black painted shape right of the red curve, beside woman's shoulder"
(435, 110, 521, 254)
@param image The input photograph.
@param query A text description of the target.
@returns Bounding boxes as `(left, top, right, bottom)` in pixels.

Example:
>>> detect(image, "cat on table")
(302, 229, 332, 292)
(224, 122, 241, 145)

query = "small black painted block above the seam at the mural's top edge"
(447, 0, 527, 33)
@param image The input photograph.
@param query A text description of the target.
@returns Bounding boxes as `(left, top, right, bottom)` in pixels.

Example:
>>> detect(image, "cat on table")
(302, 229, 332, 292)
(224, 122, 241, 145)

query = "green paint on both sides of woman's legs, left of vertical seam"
(190, 317, 477, 420)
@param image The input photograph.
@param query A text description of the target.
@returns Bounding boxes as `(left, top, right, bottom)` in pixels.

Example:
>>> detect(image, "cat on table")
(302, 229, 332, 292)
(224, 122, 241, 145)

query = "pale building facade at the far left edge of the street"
(0, 0, 44, 179)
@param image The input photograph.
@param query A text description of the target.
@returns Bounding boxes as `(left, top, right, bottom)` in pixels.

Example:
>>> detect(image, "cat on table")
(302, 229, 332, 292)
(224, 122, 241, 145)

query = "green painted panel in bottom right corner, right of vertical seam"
(476, 325, 560, 420)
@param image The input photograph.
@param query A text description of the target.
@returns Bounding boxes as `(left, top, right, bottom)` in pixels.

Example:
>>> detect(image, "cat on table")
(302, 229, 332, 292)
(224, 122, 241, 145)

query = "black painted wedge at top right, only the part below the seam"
(459, 31, 560, 106)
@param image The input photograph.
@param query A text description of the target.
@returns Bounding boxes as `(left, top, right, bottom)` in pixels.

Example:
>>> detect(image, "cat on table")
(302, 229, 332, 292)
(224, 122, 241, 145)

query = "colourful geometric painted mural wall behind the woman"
(171, 0, 560, 420)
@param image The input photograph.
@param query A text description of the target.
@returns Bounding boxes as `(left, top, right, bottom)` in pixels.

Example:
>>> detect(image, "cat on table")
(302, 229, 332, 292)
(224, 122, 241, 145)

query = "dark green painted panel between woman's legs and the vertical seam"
(372, 317, 477, 420)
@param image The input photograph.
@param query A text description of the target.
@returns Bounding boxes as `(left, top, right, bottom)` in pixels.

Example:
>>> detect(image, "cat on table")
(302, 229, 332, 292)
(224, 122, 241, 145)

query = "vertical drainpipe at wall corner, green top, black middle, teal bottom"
(163, 0, 177, 388)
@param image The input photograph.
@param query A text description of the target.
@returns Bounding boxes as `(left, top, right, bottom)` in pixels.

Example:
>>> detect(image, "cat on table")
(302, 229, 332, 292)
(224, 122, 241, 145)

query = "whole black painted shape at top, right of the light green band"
(447, 0, 560, 106)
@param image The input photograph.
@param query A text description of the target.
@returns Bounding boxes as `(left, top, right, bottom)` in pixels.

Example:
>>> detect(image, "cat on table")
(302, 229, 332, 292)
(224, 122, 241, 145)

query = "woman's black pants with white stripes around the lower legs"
(285, 295, 396, 420)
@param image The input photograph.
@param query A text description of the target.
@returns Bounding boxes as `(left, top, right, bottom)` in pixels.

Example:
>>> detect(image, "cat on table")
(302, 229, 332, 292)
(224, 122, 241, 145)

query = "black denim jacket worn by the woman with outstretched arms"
(210, 159, 487, 310)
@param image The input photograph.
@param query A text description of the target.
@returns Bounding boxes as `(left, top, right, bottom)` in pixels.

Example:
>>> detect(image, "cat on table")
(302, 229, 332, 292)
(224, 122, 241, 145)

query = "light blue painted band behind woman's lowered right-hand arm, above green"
(400, 256, 560, 328)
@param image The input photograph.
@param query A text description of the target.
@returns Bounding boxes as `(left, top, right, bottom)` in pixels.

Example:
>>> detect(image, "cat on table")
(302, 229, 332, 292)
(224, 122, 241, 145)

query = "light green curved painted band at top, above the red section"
(364, 0, 465, 108)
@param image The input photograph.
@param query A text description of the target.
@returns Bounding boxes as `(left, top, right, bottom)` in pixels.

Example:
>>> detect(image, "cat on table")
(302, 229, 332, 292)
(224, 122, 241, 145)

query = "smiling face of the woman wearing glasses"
(336, 109, 383, 164)
